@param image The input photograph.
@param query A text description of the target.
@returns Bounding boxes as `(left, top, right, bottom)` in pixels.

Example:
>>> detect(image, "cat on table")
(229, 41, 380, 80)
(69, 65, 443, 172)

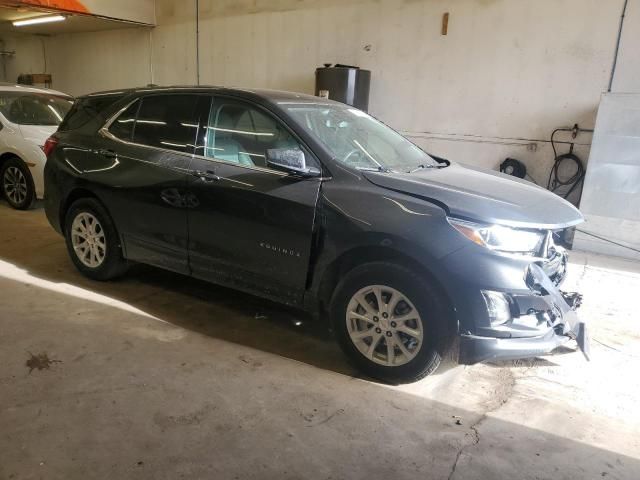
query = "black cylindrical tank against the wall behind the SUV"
(316, 63, 371, 112)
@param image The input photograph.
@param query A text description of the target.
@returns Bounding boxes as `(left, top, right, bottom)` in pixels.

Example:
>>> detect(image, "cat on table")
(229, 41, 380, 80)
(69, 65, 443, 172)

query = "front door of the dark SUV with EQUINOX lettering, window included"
(189, 96, 320, 304)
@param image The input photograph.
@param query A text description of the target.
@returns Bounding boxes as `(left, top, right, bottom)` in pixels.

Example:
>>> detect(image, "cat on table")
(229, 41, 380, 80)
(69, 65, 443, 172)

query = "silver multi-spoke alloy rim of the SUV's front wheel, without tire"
(346, 285, 424, 367)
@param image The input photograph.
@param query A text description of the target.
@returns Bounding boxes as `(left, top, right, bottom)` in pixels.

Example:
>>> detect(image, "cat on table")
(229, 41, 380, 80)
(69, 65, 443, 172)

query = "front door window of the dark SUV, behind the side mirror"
(204, 98, 300, 167)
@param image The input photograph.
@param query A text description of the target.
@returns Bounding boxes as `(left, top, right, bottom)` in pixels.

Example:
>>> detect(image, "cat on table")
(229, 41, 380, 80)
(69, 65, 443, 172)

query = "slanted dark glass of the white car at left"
(0, 92, 73, 126)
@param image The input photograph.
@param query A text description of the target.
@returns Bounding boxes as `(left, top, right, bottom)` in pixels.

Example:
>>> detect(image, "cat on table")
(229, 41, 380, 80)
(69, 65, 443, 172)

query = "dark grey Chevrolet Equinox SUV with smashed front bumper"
(45, 87, 588, 383)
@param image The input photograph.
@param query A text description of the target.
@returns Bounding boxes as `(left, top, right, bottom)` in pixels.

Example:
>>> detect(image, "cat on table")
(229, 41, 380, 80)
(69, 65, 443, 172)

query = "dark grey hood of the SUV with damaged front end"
(362, 163, 584, 229)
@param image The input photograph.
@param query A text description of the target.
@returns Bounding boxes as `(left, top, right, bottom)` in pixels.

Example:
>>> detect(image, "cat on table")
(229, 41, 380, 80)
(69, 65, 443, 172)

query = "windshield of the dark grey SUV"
(281, 103, 440, 172)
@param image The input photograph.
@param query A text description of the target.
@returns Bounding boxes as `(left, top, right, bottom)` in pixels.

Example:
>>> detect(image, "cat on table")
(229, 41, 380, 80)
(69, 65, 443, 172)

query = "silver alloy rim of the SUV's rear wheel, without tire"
(71, 212, 107, 268)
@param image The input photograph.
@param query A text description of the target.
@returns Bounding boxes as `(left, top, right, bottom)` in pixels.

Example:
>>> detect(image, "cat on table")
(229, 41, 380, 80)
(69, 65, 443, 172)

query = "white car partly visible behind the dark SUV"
(0, 84, 73, 210)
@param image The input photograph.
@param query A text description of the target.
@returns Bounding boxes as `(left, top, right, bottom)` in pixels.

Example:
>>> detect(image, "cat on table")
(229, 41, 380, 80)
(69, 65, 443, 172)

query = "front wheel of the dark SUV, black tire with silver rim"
(330, 262, 452, 384)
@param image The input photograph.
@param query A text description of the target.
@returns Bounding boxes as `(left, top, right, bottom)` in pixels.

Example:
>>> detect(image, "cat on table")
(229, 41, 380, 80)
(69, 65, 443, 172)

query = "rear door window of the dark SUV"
(131, 95, 199, 153)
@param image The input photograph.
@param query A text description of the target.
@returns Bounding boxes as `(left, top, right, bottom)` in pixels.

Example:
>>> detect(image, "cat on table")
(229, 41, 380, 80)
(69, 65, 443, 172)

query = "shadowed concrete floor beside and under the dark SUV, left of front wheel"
(0, 204, 359, 376)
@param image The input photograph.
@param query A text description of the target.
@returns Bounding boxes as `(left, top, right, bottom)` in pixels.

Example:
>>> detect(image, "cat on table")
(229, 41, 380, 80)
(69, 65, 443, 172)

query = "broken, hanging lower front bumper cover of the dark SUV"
(458, 265, 589, 365)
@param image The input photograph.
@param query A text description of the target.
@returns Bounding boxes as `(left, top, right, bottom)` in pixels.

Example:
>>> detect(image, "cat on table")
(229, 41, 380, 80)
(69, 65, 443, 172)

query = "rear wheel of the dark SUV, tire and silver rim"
(64, 198, 127, 281)
